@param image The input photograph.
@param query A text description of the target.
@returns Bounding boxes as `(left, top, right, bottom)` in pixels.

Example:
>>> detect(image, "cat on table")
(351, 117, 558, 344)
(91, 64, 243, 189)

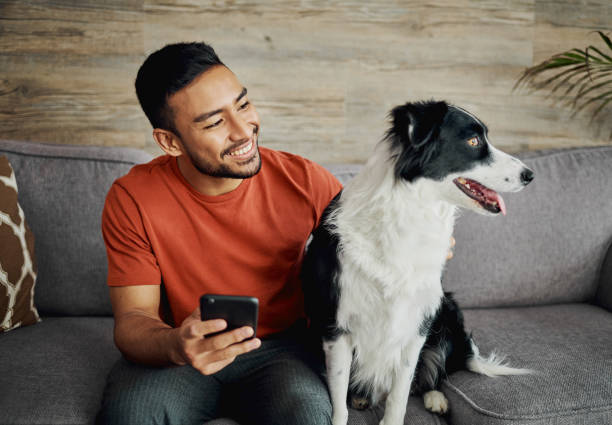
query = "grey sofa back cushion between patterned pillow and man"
(0, 140, 151, 315)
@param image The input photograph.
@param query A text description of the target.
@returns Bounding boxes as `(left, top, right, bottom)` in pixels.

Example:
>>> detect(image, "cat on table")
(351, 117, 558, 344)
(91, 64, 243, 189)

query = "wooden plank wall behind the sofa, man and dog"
(0, 0, 612, 163)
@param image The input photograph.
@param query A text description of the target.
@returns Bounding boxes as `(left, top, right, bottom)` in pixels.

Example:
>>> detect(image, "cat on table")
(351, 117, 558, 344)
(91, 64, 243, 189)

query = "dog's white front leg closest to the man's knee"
(323, 334, 353, 425)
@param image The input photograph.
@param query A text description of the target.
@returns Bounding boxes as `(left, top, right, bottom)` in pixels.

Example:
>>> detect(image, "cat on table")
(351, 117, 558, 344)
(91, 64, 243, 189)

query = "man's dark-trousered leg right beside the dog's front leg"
(224, 340, 332, 425)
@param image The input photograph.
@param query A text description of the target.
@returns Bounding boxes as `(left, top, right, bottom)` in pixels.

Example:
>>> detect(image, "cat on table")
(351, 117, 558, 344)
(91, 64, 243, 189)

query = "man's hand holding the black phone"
(173, 307, 261, 375)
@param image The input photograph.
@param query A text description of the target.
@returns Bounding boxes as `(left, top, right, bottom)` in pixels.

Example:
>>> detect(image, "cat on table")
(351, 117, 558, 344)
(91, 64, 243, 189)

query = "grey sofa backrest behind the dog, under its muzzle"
(328, 147, 612, 307)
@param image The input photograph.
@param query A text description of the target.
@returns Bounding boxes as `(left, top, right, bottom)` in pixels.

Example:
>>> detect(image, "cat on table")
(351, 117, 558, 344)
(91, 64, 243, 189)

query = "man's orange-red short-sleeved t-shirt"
(102, 148, 341, 337)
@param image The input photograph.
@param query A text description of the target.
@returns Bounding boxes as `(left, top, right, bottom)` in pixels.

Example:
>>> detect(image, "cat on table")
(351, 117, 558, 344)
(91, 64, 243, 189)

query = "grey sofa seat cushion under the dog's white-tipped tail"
(443, 304, 612, 425)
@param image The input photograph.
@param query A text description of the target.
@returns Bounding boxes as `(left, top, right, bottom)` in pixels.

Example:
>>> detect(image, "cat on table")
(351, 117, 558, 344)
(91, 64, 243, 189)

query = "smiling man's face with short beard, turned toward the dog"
(168, 66, 261, 179)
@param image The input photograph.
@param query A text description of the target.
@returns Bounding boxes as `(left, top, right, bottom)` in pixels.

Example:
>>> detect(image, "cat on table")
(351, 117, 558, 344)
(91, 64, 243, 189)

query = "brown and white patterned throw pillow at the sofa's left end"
(0, 156, 40, 332)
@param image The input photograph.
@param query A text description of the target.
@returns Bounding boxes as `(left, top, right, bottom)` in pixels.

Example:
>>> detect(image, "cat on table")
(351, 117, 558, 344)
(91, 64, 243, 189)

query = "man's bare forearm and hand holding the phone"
(110, 285, 261, 375)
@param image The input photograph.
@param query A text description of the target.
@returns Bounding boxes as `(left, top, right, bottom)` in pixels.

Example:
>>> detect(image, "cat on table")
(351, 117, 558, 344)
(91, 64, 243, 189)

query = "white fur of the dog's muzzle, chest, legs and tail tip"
(324, 143, 524, 425)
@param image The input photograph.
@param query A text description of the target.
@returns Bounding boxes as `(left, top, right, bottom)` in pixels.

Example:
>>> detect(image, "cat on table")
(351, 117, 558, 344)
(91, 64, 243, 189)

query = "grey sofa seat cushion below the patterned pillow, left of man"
(0, 317, 120, 425)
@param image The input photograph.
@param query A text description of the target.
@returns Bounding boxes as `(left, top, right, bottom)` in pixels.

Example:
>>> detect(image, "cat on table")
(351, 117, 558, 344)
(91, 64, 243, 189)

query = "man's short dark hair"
(135, 43, 223, 135)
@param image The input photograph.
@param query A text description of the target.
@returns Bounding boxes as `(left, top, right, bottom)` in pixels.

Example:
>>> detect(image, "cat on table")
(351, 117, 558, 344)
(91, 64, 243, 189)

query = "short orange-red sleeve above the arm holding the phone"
(102, 182, 161, 286)
